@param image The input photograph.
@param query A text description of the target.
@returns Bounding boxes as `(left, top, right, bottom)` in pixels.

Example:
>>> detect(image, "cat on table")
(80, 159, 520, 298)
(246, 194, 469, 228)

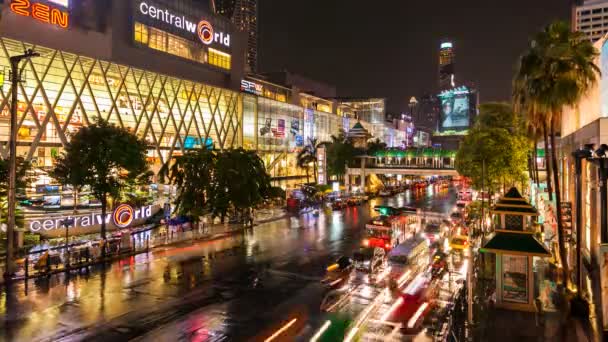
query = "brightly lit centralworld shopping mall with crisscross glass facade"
(0, 0, 403, 203)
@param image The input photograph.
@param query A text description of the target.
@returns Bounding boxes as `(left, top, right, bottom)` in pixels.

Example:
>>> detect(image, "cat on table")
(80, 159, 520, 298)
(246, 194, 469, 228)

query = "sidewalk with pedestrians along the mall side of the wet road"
(0, 209, 287, 284)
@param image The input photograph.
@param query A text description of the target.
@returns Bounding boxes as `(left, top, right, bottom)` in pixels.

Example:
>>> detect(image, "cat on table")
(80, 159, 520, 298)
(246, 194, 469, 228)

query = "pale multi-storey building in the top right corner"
(572, 0, 608, 42)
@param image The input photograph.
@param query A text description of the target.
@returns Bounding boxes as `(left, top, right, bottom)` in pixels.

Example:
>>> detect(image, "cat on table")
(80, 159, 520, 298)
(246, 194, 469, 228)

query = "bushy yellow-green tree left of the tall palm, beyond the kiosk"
(456, 104, 530, 191)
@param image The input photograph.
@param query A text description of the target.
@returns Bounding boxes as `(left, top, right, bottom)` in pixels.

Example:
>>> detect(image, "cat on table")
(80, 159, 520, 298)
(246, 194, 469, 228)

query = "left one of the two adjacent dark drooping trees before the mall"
(159, 149, 217, 222)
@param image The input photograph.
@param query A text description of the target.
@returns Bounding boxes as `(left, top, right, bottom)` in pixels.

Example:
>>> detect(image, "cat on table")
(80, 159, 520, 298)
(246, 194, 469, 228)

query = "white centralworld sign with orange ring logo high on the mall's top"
(138, 2, 230, 47)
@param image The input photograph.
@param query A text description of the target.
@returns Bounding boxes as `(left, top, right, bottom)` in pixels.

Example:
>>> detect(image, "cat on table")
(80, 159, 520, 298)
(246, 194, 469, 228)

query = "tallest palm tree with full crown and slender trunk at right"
(514, 21, 600, 288)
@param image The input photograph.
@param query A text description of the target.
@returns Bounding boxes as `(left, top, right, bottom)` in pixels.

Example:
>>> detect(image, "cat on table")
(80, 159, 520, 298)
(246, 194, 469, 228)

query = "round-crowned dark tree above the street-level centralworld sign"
(53, 119, 148, 240)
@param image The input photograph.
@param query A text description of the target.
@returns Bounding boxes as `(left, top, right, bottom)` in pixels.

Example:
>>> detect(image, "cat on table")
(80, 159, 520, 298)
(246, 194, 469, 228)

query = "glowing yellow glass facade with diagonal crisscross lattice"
(0, 38, 242, 166)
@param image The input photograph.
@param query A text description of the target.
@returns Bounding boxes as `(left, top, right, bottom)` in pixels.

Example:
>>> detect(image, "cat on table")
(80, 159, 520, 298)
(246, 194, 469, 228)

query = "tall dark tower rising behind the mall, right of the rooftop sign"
(211, 0, 258, 72)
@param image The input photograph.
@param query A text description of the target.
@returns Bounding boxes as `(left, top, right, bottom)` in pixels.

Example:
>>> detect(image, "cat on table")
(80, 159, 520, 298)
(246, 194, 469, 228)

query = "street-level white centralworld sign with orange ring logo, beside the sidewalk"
(29, 204, 152, 232)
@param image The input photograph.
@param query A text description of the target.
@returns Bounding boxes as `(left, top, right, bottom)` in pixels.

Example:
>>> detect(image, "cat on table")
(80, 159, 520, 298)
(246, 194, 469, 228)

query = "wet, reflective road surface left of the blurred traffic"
(0, 186, 456, 341)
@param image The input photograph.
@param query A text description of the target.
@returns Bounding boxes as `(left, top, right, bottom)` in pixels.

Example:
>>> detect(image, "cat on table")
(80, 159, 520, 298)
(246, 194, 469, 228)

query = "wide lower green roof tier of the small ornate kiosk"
(479, 230, 551, 257)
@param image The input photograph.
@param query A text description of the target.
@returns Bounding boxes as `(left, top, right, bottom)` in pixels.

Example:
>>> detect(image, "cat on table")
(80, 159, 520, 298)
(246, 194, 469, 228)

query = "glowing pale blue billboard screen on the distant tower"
(439, 87, 474, 132)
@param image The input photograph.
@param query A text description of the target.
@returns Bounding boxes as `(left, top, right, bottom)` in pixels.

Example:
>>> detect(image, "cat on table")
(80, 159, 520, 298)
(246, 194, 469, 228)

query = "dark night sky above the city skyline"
(259, 0, 570, 113)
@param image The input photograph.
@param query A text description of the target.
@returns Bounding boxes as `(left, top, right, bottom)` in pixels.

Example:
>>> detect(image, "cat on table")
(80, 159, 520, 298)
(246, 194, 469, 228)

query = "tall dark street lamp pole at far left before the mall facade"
(4, 49, 40, 280)
